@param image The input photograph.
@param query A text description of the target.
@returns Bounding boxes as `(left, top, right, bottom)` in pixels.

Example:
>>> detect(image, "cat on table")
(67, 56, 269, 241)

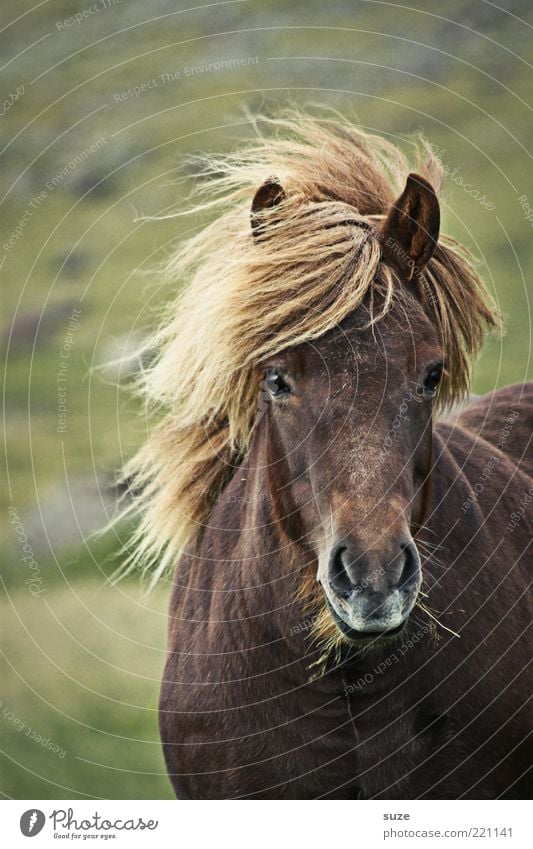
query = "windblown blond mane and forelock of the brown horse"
(124, 111, 497, 583)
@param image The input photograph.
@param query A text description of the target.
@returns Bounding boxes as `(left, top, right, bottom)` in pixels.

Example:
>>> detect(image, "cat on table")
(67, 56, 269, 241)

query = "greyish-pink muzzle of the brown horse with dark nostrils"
(318, 536, 422, 639)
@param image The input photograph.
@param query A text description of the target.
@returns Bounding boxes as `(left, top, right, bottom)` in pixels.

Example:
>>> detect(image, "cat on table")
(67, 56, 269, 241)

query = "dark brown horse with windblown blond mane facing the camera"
(121, 111, 533, 799)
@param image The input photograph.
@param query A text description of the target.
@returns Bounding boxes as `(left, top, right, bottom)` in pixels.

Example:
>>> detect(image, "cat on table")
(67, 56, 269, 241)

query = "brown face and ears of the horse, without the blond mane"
(252, 174, 446, 640)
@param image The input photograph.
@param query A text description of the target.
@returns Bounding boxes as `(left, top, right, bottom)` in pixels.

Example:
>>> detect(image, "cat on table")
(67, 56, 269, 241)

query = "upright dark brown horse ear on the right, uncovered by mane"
(380, 174, 440, 281)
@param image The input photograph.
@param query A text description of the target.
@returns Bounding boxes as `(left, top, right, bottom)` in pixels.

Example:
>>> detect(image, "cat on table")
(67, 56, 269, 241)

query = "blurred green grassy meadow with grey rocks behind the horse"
(0, 0, 533, 799)
